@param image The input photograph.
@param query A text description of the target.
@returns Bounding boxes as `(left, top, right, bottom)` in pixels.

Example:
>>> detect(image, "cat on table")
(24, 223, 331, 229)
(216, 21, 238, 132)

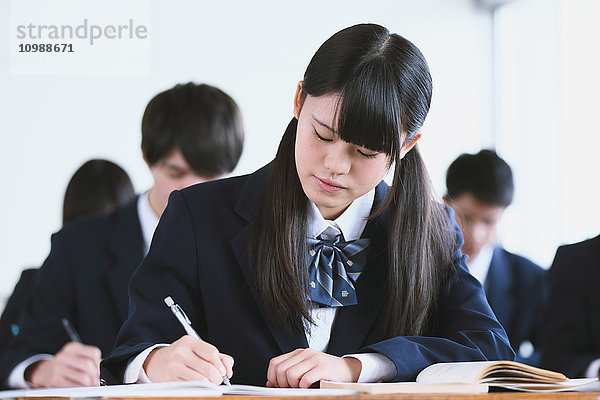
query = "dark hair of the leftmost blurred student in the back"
(63, 159, 135, 225)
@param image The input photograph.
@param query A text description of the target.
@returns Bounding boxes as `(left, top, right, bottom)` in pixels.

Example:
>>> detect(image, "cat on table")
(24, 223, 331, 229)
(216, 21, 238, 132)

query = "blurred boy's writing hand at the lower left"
(25, 342, 102, 387)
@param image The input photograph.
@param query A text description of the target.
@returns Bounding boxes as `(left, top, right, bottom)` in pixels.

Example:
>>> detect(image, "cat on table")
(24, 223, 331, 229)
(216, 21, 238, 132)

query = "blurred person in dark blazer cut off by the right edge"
(540, 236, 600, 378)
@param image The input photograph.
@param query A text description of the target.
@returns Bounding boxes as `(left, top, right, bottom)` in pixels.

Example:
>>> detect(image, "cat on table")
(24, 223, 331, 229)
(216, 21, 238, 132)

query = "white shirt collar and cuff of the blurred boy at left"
(7, 192, 159, 389)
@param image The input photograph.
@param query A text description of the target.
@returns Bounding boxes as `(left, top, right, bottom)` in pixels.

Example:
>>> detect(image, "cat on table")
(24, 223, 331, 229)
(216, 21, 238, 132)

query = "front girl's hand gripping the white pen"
(144, 335, 233, 385)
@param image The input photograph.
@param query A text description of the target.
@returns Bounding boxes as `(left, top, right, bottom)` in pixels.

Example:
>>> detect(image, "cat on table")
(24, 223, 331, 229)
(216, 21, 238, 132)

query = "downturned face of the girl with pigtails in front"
(294, 91, 392, 220)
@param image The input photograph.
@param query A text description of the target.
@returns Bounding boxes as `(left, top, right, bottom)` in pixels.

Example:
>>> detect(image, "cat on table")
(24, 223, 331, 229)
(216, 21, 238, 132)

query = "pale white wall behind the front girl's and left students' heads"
(0, 0, 492, 297)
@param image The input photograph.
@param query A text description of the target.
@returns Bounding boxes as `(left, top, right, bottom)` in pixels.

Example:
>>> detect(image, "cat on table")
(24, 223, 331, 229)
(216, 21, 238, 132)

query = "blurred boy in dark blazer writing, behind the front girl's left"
(0, 83, 244, 387)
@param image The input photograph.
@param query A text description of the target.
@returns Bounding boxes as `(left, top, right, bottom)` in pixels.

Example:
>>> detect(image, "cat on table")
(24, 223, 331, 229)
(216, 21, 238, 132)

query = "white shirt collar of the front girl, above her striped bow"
(308, 188, 375, 241)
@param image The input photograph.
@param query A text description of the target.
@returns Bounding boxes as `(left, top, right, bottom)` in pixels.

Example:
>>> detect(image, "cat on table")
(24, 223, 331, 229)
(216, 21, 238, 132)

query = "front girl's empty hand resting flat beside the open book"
(267, 349, 362, 388)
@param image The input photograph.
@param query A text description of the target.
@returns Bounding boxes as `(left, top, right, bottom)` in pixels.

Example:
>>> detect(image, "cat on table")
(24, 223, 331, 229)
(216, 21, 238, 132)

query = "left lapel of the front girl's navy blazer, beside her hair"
(231, 165, 308, 353)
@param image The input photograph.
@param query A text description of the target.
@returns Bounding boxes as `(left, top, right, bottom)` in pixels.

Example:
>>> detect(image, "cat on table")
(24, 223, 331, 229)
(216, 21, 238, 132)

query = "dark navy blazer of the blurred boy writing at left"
(0, 198, 144, 383)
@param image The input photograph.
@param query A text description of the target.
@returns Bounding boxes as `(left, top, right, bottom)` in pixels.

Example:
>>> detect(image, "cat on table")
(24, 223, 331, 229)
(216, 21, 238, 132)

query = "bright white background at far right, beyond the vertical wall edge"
(496, 0, 600, 267)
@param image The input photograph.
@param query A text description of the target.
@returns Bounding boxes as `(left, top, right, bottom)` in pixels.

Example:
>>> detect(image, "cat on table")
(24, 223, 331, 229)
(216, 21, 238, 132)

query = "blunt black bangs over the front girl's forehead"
(336, 57, 402, 160)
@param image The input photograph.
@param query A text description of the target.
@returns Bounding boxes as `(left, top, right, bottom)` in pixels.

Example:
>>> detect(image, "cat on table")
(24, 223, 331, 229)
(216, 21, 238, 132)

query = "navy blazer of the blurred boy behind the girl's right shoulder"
(484, 246, 546, 365)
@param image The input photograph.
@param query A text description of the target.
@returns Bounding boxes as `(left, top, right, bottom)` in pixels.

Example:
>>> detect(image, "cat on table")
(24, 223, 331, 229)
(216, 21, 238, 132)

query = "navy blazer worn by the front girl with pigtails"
(102, 166, 514, 385)
